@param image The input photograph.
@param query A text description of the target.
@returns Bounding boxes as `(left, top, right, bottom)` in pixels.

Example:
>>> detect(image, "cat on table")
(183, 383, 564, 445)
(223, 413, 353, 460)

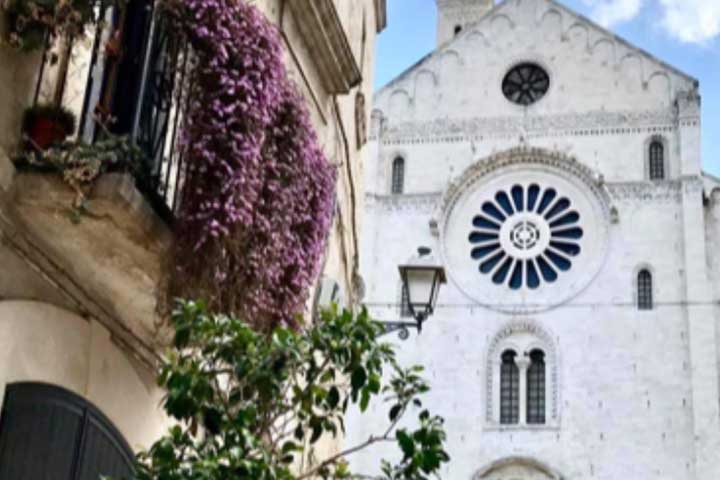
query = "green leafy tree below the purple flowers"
(126, 302, 449, 480)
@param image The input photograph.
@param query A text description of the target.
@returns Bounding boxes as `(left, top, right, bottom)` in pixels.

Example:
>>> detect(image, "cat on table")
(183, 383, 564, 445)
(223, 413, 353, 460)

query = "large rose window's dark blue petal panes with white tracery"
(468, 184, 583, 290)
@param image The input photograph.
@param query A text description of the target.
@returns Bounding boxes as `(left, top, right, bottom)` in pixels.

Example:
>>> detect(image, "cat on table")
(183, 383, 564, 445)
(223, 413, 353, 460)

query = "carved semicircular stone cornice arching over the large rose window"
(434, 145, 611, 225)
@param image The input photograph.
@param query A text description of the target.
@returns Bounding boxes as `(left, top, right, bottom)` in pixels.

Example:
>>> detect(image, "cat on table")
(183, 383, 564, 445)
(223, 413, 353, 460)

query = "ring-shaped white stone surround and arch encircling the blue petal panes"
(438, 146, 612, 315)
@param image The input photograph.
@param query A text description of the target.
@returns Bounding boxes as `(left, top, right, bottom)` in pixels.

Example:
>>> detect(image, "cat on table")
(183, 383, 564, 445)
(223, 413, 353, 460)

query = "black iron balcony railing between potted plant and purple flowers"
(65, 0, 193, 222)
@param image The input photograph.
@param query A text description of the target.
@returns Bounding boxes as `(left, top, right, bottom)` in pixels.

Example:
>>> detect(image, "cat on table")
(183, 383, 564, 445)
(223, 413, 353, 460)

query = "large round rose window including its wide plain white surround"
(442, 166, 607, 312)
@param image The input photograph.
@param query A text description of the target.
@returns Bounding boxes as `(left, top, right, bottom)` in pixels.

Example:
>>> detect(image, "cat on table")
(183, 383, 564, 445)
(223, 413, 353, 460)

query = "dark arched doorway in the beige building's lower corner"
(0, 383, 134, 480)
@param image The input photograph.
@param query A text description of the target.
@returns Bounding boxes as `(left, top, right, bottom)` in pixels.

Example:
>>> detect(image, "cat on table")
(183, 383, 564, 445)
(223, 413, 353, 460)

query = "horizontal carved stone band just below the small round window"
(380, 110, 677, 143)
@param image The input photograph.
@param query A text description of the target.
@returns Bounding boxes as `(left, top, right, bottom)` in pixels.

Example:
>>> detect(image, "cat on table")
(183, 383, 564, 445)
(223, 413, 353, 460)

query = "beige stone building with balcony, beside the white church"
(0, 0, 386, 474)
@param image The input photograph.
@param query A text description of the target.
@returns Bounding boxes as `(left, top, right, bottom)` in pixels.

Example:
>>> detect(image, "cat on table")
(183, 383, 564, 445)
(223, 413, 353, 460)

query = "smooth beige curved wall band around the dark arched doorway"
(0, 301, 168, 450)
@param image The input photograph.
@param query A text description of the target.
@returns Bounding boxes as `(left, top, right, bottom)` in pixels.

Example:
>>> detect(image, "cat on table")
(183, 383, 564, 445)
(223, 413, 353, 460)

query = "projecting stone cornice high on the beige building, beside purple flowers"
(288, 0, 362, 94)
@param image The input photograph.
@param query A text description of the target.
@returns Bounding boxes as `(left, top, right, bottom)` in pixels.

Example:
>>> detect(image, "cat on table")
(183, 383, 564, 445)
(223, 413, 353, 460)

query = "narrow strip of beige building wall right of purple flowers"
(264, 0, 378, 304)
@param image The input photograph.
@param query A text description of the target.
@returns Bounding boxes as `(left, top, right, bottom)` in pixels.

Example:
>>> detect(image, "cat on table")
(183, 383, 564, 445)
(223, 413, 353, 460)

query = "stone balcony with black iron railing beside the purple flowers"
(0, 0, 191, 363)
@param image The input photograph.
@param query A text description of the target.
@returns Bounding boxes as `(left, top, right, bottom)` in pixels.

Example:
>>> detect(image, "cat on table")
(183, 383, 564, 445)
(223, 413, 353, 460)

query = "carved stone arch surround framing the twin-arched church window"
(485, 319, 560, 425)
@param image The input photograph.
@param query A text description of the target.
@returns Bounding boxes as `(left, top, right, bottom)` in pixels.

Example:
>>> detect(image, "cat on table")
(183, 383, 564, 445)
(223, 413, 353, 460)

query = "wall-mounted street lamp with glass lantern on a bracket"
(383, 247, 447, 340)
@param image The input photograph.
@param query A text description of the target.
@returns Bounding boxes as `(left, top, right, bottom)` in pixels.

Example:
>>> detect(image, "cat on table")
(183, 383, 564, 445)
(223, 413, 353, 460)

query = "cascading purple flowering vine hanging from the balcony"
(166, 0, 336, 329)
